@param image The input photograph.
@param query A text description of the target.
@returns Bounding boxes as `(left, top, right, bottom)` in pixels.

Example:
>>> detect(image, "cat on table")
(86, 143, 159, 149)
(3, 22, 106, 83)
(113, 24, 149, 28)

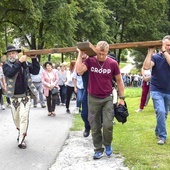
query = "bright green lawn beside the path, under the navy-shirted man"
(71, 88, 170, 170)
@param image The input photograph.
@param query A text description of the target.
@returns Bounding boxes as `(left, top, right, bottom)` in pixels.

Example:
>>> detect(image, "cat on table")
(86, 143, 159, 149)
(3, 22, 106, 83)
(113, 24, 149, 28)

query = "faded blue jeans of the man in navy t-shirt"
(150, 91, 170, 140)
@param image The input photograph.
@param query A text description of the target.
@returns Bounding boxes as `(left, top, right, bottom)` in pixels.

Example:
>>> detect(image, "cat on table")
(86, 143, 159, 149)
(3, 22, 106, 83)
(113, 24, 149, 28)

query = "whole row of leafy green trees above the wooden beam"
(0, 0, 170, 65)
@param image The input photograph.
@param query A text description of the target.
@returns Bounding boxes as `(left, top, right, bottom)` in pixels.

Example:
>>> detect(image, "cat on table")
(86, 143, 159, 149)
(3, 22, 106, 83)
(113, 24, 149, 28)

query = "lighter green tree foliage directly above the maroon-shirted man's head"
(75, 0, 111, 44)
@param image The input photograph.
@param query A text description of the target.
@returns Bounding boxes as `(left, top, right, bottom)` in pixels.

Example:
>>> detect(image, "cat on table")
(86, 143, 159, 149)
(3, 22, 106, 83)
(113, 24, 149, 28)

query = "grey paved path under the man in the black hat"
(0, 101, 75, 170)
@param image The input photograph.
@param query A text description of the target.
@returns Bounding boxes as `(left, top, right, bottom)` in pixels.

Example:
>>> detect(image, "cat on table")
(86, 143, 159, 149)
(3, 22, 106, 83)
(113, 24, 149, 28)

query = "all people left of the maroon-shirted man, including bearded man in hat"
(0, 45, 93, 149)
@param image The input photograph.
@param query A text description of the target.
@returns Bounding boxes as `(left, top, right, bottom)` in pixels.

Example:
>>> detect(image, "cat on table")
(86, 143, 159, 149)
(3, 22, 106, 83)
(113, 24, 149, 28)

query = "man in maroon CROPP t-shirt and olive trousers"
(76, 41, 124, 159)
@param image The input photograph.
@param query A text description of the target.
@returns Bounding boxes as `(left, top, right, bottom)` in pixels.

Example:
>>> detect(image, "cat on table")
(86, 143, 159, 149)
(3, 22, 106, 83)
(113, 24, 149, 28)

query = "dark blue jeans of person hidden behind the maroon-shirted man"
(81, 89, 90, 130)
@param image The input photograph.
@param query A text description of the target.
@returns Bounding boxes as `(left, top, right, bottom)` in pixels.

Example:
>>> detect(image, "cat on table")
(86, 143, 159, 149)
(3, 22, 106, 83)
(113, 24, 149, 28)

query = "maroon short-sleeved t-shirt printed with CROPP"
(84, 57, 120, 98)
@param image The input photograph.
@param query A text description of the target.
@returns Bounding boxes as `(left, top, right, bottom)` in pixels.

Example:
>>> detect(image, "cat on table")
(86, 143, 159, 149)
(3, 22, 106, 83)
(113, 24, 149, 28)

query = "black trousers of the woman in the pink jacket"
(46, 91, 57, 112)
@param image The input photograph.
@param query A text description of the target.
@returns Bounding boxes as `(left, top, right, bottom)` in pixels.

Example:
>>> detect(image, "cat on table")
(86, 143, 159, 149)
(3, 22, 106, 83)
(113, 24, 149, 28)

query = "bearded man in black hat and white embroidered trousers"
(3, 45, 40, 149)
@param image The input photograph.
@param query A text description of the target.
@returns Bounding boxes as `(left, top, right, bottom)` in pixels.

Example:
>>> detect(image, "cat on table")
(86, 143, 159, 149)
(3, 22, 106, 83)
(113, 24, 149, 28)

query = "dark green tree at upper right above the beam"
(107, 0, 170, 61)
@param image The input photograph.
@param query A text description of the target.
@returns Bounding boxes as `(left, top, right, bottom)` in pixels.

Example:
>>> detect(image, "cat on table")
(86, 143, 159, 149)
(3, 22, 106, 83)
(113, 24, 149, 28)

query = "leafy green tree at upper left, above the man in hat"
(1, 0, 76, 49)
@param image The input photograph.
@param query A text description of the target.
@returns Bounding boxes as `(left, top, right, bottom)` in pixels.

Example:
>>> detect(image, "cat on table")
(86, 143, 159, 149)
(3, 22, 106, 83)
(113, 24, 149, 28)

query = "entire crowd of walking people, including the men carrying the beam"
(0, 35, 170, 159)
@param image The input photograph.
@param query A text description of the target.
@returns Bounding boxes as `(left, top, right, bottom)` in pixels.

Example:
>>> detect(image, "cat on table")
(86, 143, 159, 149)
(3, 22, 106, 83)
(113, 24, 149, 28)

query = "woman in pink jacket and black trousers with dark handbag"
(42, 61, 59, 116)
